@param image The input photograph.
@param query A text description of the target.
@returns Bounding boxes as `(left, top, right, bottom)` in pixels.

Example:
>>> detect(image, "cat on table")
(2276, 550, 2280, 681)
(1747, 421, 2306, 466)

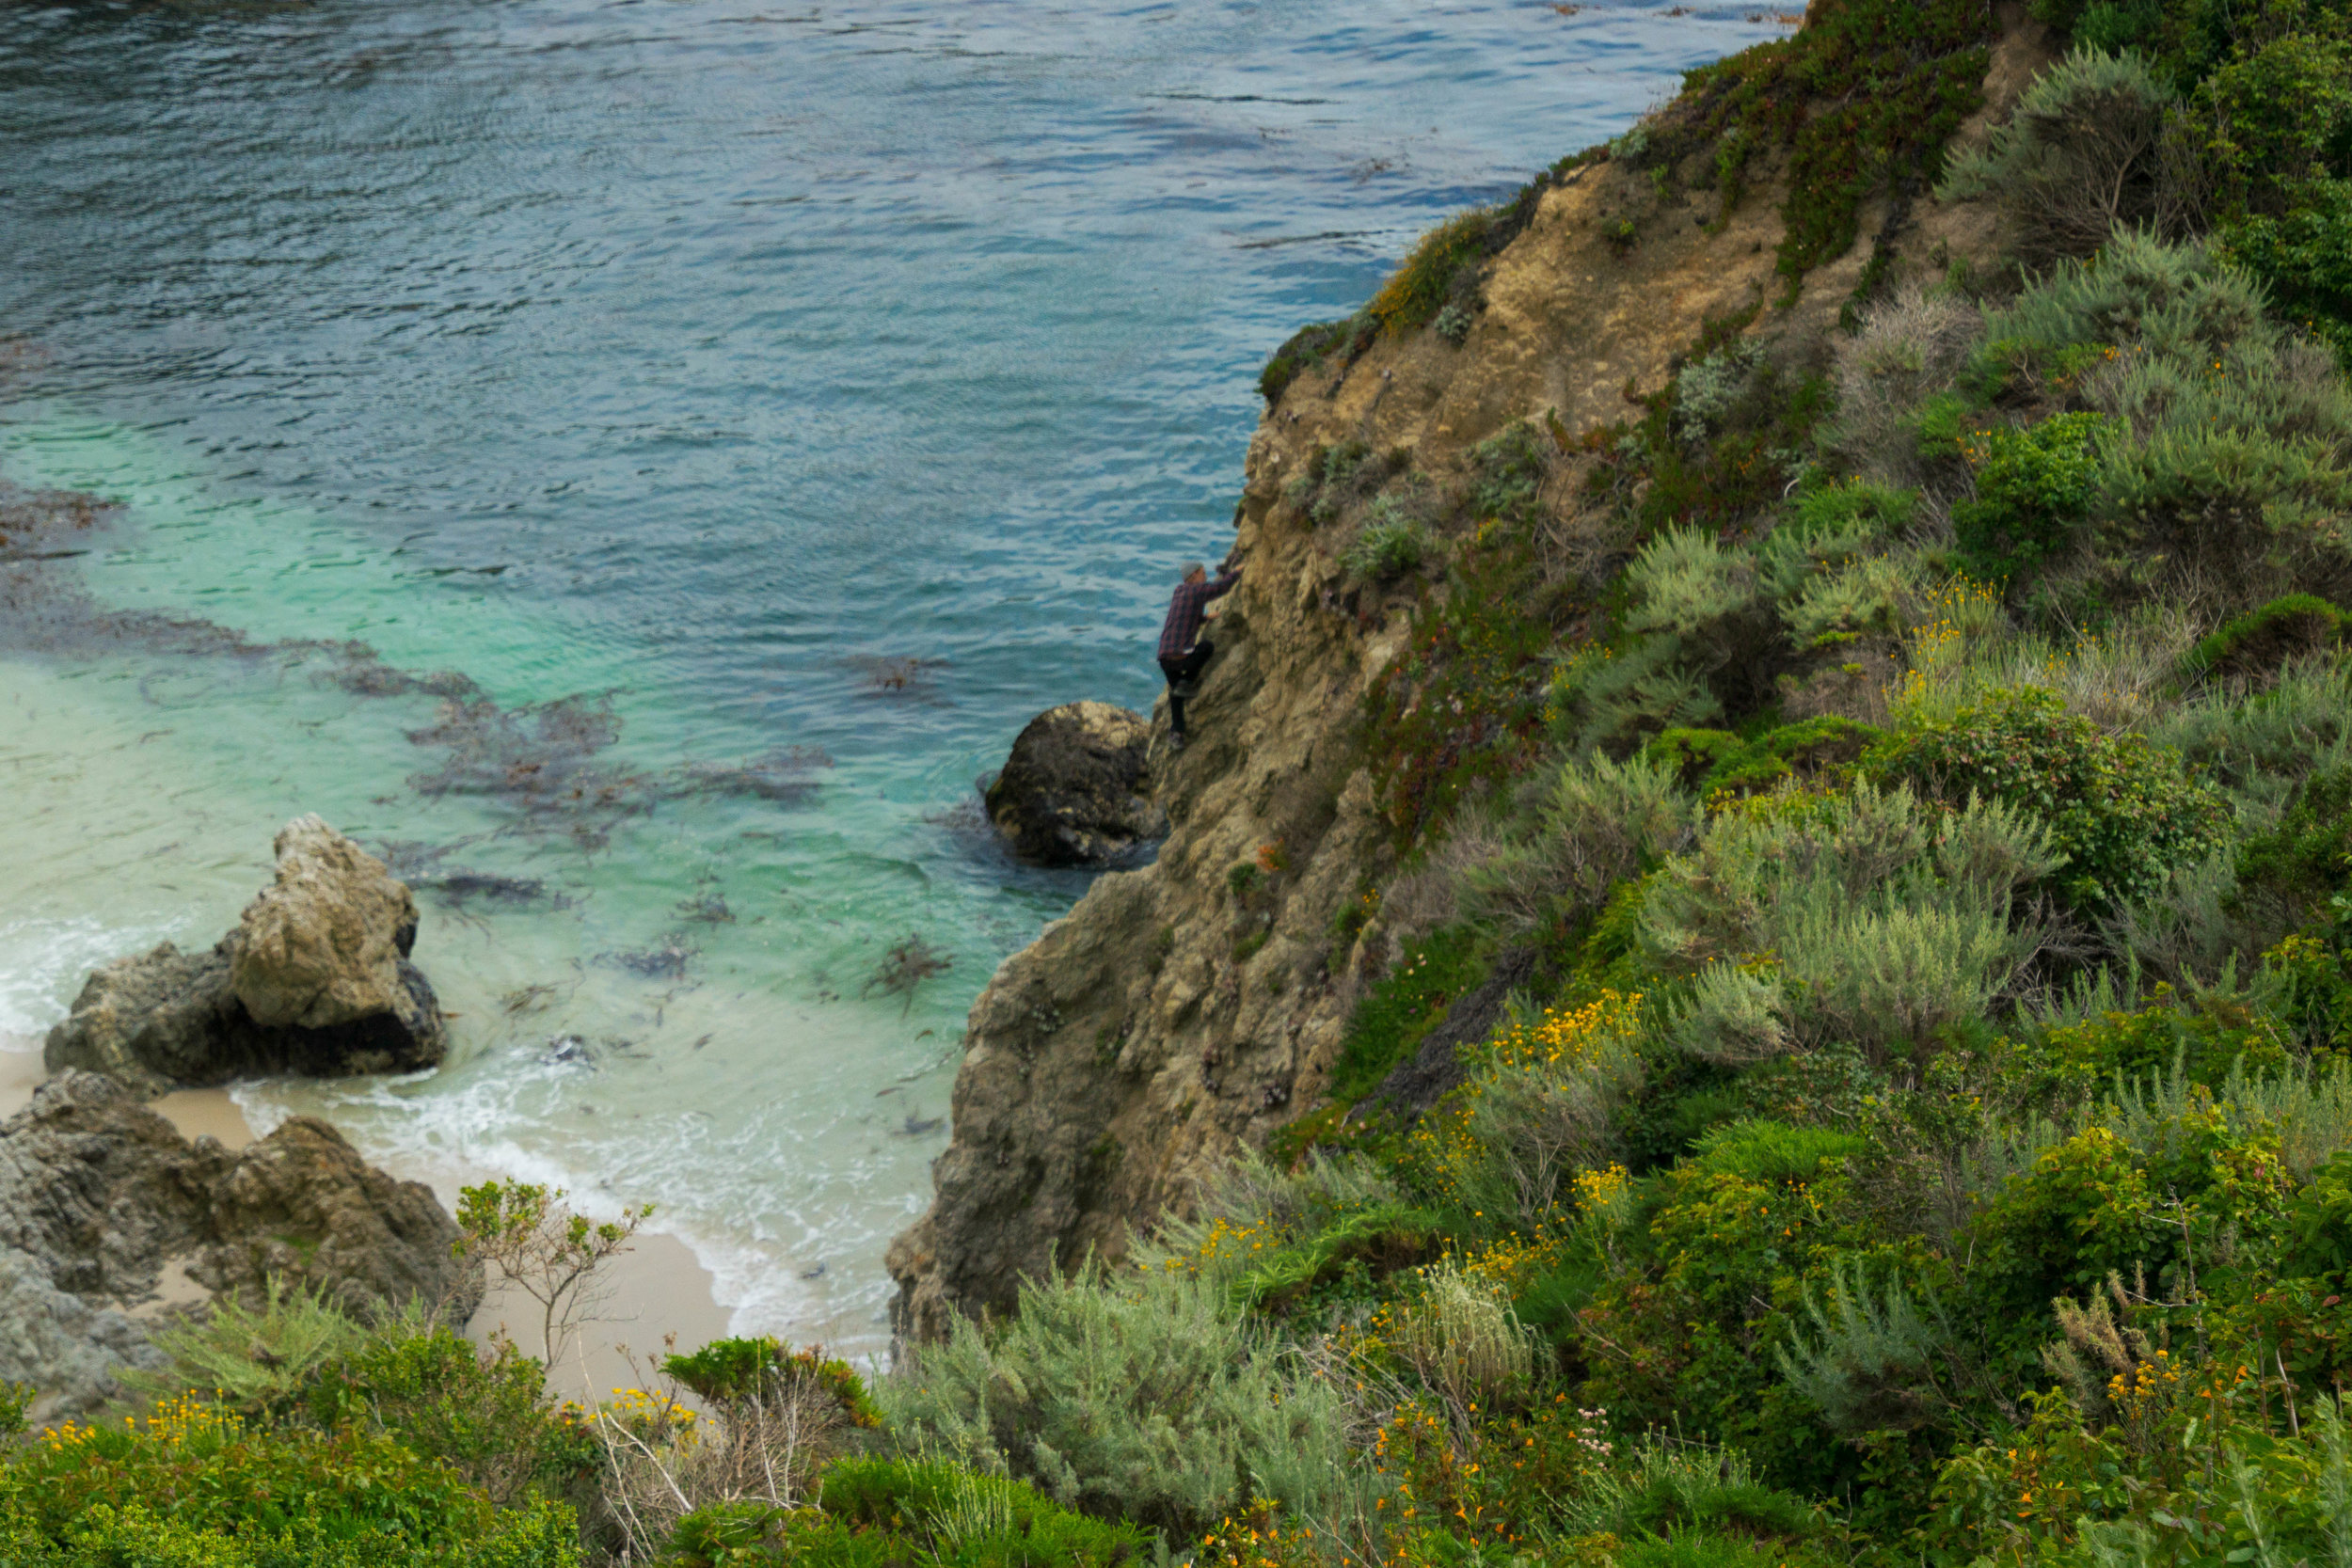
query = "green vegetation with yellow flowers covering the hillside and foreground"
(23, 0, 2352, 1568)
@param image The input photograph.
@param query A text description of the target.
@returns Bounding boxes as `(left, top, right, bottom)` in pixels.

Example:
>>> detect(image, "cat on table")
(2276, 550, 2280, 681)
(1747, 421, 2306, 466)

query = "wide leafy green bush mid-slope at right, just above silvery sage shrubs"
(1863, 687, 2230, 912)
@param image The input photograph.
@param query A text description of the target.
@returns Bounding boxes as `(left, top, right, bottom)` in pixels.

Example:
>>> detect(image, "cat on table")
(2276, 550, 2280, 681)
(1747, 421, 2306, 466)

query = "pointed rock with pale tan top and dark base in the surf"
(45, 816, 447, 1096)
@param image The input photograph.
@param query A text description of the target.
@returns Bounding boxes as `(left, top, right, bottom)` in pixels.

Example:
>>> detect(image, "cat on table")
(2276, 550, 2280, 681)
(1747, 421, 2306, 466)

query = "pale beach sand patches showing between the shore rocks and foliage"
(0, 1035, 732, 1399)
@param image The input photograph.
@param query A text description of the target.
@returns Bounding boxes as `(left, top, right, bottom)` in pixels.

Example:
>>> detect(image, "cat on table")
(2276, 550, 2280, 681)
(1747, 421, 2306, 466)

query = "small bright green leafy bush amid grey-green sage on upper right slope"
(1952, 414, 2107, 585)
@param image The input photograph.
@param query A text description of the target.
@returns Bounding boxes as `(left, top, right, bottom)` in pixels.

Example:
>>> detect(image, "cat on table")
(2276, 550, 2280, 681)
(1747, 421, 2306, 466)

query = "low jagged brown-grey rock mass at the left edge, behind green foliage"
(0, 1072, 483, 1420)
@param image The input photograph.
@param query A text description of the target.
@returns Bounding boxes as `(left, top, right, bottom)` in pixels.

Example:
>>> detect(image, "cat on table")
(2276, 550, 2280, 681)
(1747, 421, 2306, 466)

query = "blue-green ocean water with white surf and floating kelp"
(0, 0, 1788, 1350)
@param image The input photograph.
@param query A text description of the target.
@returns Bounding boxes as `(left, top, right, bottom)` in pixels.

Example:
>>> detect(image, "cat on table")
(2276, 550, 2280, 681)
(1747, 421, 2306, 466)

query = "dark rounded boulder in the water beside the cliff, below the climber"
(988, 703, 1169, 865)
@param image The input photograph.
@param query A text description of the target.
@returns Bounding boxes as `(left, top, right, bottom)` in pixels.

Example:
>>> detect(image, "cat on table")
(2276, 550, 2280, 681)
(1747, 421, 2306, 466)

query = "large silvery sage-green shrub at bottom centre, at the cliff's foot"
(875, 1270, 1350, 1530)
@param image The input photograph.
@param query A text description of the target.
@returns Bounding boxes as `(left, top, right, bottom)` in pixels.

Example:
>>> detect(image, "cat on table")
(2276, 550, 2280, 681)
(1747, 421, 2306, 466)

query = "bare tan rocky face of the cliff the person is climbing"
(889, 15, 2023, 1338)
